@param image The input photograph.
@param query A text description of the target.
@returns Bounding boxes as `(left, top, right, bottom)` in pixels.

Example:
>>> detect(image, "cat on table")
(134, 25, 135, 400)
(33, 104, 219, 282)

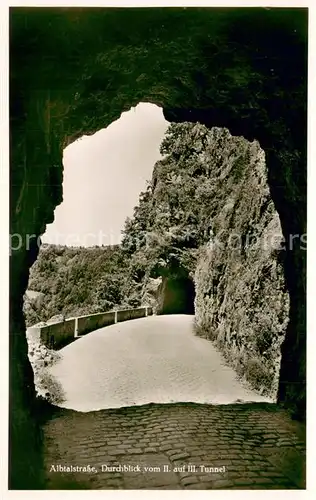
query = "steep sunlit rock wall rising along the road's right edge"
(195, 129, 289, 398)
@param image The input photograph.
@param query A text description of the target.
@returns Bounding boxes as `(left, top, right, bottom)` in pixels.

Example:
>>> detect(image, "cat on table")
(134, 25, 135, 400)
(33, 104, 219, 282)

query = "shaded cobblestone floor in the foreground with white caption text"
(43, 403, 305, 490)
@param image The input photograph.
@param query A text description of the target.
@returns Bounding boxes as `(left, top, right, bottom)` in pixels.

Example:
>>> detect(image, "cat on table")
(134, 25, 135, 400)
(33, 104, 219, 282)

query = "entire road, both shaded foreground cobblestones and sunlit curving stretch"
(43, 316, 305, 490)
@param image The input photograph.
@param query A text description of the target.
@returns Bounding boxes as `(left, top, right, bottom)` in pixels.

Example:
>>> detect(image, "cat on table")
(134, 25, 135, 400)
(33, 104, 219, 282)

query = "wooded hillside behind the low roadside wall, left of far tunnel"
(24, 245, 127, 326)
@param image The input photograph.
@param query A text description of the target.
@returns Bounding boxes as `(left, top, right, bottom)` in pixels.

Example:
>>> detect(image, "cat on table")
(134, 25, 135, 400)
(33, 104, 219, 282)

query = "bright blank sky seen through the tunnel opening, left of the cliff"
(42, 103, 169, 246)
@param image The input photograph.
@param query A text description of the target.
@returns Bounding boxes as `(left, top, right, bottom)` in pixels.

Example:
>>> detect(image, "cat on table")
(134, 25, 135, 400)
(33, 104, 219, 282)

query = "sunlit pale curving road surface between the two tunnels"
(50, 315, 270, 412)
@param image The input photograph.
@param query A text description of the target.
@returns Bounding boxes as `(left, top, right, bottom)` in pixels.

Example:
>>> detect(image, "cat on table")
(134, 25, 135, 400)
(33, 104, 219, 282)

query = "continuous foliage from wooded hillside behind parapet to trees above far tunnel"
(24, 123, 233, 325)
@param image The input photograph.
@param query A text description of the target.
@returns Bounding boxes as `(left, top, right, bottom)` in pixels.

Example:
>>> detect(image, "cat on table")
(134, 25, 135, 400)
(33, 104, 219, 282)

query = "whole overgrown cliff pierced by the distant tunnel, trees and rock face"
(123, 123, 289, 396)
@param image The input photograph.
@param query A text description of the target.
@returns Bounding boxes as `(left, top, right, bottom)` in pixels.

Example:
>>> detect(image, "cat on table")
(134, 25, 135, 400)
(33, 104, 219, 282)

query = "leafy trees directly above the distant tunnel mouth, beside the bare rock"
(122, 123, 222, 286)
